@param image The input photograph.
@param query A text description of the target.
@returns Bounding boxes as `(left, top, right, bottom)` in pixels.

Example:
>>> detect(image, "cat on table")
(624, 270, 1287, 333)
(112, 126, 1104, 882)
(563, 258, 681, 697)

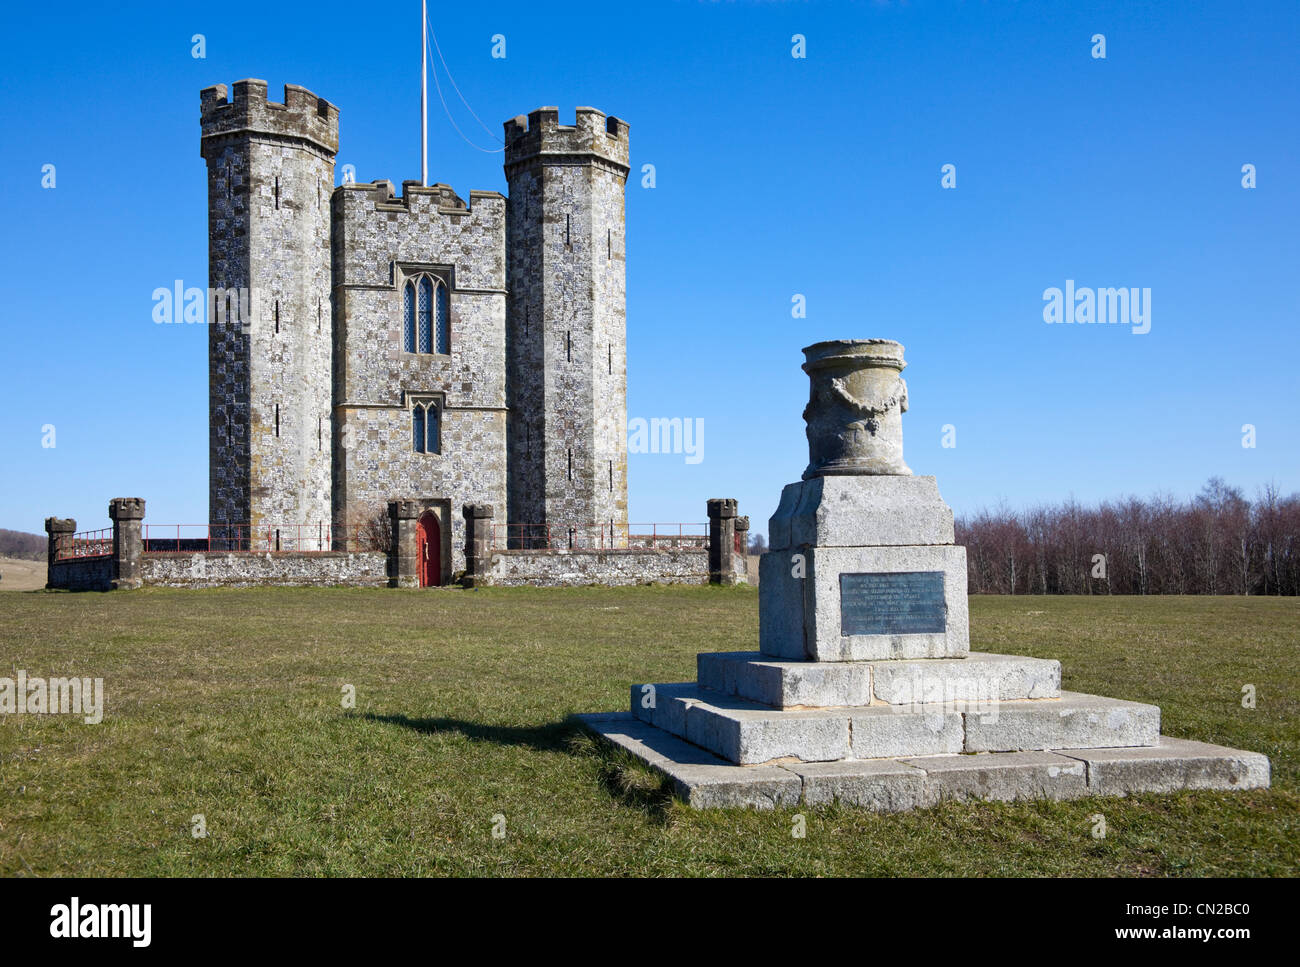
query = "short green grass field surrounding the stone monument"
(0, 587, 1300, 876)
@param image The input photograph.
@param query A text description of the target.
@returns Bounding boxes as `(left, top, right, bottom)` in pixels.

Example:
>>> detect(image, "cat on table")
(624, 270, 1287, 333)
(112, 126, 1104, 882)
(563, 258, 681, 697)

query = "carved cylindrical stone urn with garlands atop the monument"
(803, 339, 911, 480)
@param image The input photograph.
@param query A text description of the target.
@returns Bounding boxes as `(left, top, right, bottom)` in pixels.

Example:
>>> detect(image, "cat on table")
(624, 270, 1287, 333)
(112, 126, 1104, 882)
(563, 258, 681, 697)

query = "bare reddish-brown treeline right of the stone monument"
(957, 477, 1300, 594)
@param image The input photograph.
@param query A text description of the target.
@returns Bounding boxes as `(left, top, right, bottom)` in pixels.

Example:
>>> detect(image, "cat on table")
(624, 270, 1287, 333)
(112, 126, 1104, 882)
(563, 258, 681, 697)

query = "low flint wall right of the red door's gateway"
(482, 547, 728, 587)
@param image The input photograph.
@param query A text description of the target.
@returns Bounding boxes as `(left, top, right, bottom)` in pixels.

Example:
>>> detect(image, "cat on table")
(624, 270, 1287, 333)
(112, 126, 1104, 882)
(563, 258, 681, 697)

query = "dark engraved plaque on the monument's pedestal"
(840, 571, 948, 634)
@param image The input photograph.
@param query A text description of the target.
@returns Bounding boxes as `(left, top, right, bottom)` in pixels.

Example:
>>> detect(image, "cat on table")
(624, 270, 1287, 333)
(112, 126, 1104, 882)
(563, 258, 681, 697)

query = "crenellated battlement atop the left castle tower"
(199, 79, 338, 156)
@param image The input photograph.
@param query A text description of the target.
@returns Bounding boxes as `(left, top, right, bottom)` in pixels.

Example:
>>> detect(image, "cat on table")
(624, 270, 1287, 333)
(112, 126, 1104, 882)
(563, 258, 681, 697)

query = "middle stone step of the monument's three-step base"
(631, 682, 1160, 766)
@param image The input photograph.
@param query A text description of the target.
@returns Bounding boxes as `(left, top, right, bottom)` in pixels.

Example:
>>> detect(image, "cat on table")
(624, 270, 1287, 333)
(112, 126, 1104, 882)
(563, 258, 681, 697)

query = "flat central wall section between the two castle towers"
(334, 176, 507, 576)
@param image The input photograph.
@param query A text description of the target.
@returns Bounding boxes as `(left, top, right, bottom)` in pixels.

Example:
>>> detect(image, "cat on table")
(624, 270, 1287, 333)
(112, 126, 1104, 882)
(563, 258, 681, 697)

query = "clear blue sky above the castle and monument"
(0, 0, 1300, 532)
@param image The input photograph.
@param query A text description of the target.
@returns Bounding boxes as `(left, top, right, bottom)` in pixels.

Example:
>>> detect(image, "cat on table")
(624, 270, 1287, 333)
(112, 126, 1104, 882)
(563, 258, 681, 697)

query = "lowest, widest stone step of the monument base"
(577, 712, 1270, 812)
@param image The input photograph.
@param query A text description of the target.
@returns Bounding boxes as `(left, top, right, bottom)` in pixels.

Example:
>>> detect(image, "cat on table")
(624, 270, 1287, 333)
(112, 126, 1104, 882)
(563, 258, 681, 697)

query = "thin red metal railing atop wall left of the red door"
(143, 524, 389, 554)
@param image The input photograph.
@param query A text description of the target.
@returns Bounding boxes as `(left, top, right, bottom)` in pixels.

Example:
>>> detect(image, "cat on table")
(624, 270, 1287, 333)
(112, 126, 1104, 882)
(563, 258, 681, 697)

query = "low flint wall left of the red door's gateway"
(140, 551, 389, 587)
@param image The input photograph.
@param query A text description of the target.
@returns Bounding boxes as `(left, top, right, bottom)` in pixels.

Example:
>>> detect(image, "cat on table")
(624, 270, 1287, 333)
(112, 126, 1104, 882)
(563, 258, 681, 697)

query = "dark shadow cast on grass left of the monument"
(350, 712, 673, 824)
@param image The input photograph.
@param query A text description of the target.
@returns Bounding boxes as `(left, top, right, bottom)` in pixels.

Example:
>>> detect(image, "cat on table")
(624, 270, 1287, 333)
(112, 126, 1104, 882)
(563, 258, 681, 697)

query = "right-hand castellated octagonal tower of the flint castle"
(506, 108, 628, 539)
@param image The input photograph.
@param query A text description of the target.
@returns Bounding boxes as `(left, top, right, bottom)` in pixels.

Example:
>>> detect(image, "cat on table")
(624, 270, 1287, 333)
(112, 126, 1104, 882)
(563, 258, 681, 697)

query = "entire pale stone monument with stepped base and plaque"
(579, 339, 1270, 811)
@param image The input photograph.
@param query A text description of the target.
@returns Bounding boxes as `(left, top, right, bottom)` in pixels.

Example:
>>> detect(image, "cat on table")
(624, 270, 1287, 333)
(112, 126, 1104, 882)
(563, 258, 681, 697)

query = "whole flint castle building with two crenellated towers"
(200, 79, 628, 582)
